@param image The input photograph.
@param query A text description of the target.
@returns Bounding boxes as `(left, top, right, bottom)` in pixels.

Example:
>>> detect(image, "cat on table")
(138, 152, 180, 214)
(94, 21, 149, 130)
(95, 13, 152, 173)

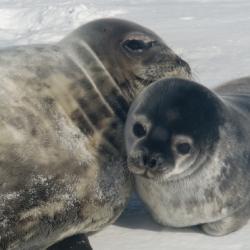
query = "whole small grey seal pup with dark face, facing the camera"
(126, 78, 250, 236)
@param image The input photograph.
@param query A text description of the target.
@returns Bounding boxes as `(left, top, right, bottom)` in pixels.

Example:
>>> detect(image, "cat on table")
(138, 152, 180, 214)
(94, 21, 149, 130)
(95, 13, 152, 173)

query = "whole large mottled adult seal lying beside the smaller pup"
(0, 19, 190, 250)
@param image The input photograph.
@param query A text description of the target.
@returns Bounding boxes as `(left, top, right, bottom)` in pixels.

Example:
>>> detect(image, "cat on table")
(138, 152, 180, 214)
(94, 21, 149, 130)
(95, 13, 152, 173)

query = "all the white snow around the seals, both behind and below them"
(0, 0, 250, 250)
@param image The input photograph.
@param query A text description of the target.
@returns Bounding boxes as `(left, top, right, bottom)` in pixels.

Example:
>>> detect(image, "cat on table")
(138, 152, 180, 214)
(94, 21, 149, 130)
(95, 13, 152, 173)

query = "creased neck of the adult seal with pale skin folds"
(52, 40, 134, 137)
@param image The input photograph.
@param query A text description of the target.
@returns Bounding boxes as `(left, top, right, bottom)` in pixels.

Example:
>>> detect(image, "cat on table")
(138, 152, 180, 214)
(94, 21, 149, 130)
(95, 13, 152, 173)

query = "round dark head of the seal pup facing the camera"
(125, 78, 224, 181)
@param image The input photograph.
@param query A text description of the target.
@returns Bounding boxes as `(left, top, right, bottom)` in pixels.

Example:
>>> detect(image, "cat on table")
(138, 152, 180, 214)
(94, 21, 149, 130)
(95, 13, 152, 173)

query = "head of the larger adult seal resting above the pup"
(62, 18, 191, 101)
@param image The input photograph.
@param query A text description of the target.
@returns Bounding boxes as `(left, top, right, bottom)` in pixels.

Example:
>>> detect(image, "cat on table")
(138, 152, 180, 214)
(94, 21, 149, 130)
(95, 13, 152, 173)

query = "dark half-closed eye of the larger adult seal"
(122, 39, 154, 53)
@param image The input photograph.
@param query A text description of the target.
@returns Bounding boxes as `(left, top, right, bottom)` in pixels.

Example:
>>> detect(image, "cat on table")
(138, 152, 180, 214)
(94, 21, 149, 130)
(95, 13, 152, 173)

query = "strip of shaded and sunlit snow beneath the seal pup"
(90, 194, 250, 250)
